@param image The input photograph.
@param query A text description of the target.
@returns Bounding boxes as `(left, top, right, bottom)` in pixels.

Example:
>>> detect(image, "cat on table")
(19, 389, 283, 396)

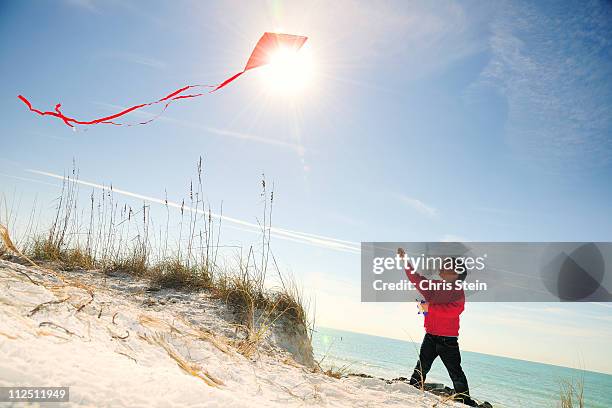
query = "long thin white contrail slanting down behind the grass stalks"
(26, 169, 360, 253)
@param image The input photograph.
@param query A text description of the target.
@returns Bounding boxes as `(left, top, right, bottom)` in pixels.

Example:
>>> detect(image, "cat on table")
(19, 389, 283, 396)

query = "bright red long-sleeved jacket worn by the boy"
(406, 268, 465, 336)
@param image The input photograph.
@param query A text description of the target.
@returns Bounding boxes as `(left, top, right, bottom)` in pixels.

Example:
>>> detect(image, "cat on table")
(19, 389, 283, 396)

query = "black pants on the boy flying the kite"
(410, 333, 473, 405)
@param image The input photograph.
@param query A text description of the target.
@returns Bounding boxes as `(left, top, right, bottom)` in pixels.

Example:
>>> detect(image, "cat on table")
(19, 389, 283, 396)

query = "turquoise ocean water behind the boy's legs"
(313, 327, 612, 408)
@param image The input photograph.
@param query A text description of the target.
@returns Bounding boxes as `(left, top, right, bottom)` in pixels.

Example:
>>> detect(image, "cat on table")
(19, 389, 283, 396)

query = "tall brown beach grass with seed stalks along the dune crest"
(0, 159, 314, 356)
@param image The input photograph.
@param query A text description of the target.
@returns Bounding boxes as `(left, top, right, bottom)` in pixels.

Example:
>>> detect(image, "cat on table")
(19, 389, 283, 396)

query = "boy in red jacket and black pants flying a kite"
(397, 248, 477, 406)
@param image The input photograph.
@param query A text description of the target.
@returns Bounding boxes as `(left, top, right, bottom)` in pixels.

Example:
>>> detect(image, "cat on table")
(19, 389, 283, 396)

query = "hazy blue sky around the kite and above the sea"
(0, 0, 612, 372)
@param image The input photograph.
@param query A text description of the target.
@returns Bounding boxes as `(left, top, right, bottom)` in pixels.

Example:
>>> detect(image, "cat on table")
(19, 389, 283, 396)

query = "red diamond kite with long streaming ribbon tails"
(18, 33, 308, 127)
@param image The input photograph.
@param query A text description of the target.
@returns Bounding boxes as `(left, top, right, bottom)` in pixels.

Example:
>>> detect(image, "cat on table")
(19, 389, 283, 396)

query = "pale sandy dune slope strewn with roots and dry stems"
(0, 261, 463, 407)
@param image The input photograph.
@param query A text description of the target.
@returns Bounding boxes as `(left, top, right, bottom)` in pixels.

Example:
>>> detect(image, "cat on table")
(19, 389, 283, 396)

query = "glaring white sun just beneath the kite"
(262, 47, 314, 95)
